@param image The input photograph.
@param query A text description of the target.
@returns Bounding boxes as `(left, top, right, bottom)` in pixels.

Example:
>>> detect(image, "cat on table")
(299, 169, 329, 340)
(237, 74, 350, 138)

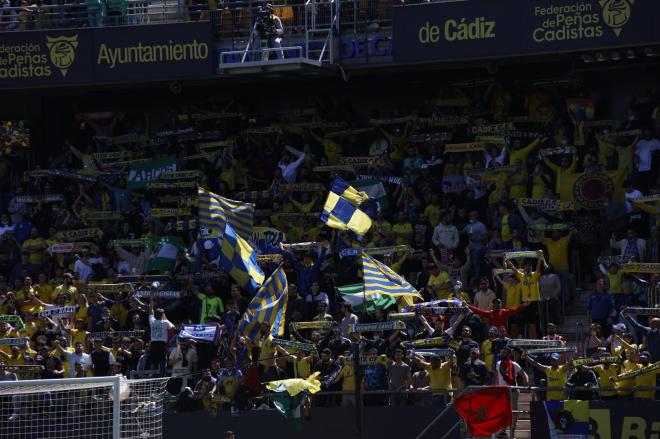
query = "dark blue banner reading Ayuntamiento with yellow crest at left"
(0, 21, 215, 88)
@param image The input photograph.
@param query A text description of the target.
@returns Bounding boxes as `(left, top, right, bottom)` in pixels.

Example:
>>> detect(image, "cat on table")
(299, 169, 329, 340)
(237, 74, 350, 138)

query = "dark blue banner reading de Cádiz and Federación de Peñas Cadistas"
(392, 0, 660, 63)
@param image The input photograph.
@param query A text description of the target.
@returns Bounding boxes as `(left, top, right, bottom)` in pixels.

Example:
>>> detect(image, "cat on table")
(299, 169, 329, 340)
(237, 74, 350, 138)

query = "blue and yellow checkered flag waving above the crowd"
(321, 177, 371, 237)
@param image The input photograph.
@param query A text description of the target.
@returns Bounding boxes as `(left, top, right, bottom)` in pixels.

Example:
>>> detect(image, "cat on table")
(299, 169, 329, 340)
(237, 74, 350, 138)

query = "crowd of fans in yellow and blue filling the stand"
(0, 78, 660, 426)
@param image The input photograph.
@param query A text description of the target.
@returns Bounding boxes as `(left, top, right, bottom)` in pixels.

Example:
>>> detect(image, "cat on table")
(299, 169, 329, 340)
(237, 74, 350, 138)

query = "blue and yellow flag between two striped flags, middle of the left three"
(220, 221, 265, 293)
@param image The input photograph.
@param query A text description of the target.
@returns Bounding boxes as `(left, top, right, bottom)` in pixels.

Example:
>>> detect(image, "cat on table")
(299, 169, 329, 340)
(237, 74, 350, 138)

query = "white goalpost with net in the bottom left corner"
(0, 376, 168, 439)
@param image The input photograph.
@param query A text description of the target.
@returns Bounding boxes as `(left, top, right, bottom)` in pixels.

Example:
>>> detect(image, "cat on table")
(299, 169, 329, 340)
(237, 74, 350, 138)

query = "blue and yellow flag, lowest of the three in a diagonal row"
(238, 264, 289, 343)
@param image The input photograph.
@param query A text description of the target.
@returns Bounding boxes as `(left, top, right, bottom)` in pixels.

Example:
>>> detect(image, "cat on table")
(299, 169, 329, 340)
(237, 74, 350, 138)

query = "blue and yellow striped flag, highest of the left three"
(197, 187, 254, 241)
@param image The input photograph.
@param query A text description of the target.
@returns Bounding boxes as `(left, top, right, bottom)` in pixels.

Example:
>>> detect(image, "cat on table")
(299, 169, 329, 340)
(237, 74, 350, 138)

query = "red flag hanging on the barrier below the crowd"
(453, 386, 513, 436)
